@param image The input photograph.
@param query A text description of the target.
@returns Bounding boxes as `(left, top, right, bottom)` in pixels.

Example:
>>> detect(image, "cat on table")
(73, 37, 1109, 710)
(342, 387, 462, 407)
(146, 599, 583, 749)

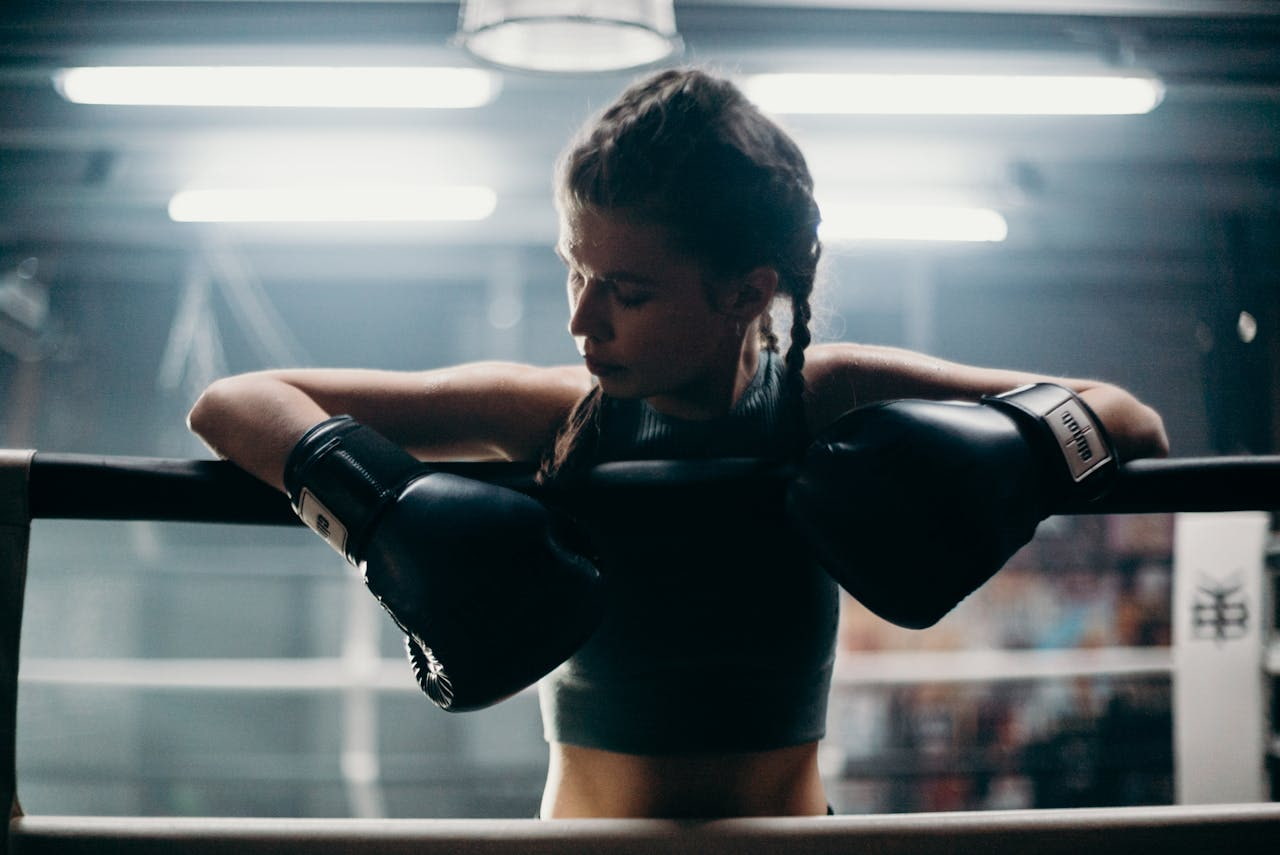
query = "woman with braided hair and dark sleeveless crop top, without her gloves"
(189, 69, 1167, 818)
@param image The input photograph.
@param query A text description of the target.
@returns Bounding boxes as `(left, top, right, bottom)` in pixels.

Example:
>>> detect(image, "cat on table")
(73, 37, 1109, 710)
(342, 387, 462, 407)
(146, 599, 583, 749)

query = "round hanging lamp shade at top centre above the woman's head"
(458, 0, 682, 73)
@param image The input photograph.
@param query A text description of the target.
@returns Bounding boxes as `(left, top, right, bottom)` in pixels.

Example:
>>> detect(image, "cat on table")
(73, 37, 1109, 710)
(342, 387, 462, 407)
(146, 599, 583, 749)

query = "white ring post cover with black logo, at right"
(1174, 511, 1280, 803)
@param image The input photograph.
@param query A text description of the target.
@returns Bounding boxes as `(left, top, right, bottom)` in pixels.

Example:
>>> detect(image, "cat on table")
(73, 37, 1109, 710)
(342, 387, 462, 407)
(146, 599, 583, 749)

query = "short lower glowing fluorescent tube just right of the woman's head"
(818, 205, 1009, 243)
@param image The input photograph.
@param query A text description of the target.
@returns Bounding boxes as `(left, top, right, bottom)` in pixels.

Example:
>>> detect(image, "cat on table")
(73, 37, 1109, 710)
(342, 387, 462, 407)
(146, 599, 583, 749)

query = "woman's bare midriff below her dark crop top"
(541, 742, 827, 819)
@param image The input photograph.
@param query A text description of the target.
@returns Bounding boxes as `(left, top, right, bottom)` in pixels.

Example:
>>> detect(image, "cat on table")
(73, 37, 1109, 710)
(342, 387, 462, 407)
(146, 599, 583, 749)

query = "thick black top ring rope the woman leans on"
(22, 452, 1280, 525)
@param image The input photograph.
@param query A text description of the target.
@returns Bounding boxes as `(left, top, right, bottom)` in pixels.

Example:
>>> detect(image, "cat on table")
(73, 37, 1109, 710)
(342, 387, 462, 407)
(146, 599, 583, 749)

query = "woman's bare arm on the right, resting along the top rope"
(805, 344, 1169, 459)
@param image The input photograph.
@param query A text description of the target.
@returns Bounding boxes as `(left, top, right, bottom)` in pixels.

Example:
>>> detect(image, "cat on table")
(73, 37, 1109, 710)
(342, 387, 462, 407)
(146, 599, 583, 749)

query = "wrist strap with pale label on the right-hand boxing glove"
(982, 383, 1119, 499)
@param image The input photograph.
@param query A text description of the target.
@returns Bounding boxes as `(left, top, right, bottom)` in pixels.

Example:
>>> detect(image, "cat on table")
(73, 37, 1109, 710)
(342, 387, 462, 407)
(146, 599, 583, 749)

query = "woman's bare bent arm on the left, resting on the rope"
(187, 362, 590, 488)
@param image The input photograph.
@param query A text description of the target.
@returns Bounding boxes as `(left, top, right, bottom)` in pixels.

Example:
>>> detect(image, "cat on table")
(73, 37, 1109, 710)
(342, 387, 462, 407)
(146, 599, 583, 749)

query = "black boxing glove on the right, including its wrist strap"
(786, 383, 1117, 628)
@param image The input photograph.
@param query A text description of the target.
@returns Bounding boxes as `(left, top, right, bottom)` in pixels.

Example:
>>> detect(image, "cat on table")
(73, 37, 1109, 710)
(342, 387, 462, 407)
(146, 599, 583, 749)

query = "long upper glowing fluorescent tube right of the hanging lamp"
(742, 74, 1165, 115)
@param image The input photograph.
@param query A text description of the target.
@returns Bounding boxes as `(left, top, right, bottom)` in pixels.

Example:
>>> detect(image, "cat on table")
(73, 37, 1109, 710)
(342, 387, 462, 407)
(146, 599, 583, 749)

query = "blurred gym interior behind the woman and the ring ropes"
(0, 0, 1280, 817)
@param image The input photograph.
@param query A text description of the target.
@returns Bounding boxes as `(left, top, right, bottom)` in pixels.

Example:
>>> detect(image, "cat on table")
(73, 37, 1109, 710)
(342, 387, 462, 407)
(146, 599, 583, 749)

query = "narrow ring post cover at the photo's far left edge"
(0, 449, 35, 855)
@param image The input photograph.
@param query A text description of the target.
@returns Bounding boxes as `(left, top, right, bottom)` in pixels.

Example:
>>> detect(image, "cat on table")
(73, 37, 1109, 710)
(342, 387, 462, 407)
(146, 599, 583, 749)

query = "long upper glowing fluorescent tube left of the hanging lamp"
(54, 65, 499, 108)
